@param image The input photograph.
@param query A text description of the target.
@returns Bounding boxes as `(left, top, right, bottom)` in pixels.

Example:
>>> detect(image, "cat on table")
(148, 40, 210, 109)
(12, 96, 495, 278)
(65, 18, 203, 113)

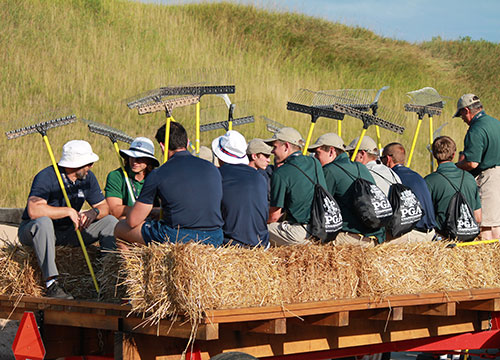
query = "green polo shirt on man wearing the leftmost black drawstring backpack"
(270, 151, 326, 224)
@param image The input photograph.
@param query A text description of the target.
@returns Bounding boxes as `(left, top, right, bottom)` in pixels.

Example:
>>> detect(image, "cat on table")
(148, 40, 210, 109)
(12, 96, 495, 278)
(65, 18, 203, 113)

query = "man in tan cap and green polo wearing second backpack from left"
(308, 133, 385, 247)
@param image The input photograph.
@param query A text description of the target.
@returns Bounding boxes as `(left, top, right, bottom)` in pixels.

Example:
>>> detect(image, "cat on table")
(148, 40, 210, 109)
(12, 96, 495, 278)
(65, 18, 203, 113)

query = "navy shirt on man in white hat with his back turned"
(219, 164, 269, 247)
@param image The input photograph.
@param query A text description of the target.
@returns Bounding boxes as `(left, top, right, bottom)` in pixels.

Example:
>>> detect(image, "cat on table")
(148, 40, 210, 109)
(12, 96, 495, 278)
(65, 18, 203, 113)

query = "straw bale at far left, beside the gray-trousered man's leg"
(0, 243, 44, 296)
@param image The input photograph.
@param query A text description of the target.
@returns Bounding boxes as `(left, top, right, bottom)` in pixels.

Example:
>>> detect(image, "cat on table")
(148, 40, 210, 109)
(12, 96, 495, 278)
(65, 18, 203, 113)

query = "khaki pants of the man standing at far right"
(472, 166, 500, 227)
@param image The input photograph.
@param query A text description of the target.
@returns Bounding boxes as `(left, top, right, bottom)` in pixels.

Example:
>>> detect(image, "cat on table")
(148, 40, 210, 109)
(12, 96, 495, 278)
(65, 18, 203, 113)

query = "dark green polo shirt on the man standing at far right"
(464, 111, 500, 176)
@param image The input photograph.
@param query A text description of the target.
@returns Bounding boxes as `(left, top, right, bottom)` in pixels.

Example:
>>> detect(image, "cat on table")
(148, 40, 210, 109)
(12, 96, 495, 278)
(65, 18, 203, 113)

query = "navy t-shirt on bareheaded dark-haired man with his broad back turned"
(137, 151, 223, 231)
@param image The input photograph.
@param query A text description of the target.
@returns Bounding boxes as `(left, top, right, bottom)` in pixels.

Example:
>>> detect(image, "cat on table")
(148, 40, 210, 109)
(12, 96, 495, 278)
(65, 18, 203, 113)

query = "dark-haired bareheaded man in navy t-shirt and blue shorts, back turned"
(115, 122, 223, 246)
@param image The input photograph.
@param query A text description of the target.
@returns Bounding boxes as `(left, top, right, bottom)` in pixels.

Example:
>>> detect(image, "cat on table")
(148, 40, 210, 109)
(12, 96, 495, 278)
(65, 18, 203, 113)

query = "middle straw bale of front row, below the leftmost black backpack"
(269, 244, 363, 303)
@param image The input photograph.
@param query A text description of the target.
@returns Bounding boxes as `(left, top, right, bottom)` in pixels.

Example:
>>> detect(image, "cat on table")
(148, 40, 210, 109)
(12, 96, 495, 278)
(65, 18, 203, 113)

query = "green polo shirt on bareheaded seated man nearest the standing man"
(425, 161, 481, 230)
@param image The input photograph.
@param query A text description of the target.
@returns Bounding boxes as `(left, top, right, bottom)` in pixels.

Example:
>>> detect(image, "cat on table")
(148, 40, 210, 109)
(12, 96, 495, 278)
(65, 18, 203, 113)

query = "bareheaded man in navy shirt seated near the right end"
(381, 142, 436, 240)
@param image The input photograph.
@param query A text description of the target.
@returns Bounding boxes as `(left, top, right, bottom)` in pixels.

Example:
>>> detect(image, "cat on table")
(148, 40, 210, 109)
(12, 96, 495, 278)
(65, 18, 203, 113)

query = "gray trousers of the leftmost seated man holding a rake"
(17, 215, 118, 280)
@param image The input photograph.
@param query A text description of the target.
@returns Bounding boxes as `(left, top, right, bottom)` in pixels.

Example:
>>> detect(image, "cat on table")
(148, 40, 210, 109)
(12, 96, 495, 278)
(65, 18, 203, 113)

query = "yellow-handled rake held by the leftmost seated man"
(5, 115, 99, 293)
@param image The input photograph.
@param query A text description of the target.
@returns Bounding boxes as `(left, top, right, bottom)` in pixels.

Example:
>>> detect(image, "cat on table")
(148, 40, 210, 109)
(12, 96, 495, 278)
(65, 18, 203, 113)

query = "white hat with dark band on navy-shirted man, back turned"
(212, 130, 248, 165)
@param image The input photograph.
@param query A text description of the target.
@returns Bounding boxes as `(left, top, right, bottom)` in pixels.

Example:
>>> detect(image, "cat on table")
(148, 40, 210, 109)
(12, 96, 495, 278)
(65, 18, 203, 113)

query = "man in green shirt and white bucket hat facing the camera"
(104, 137, 160, 219)
